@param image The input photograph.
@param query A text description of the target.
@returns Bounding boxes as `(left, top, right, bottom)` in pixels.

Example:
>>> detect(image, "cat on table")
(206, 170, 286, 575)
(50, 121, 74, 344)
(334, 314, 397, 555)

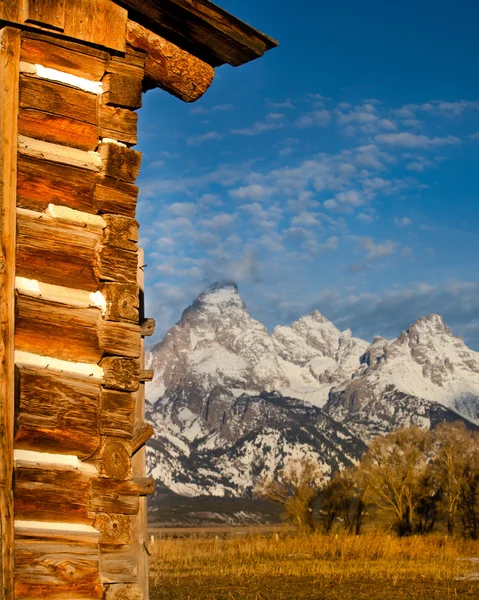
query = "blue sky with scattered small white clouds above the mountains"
(134, 0, 479, 350)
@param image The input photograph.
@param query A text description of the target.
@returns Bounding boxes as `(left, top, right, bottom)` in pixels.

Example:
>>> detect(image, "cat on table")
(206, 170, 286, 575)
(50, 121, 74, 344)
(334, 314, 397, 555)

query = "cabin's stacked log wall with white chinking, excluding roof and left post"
(14, 31, 156, 600)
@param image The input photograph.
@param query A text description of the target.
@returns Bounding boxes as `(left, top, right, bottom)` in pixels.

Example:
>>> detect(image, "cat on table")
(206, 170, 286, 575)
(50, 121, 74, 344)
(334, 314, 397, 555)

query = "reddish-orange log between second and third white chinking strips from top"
(17, 156, 98, 214)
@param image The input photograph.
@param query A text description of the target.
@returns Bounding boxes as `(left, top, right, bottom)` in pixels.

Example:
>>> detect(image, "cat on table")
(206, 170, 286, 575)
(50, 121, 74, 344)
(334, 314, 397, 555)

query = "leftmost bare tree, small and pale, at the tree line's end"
(256, 457, 321, 532)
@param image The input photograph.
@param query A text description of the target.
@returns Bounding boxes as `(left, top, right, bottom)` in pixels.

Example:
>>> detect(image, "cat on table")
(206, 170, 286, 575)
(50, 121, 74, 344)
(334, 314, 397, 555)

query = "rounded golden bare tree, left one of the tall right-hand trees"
(360, 427, 431, 535)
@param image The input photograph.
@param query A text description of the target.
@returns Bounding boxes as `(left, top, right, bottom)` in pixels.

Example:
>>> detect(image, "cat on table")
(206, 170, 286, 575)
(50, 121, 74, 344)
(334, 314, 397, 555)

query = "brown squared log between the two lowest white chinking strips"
(14, 461, 94, 525)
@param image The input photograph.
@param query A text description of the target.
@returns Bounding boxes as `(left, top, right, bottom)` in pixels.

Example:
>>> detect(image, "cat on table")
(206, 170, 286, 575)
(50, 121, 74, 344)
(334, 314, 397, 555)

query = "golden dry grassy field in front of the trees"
(150, 534, 479, 600)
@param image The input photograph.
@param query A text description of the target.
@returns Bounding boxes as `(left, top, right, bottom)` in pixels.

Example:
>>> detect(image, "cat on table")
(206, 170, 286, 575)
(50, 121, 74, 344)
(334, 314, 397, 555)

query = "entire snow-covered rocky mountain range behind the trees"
(147, 284, 479, 497)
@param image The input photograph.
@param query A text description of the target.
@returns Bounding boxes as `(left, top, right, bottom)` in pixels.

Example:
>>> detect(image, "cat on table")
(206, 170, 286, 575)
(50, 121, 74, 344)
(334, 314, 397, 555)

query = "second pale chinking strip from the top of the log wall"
(18, 135, 101, 172)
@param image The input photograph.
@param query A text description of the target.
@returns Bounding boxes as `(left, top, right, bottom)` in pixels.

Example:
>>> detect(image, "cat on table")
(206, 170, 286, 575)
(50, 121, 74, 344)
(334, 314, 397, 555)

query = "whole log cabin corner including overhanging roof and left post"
(0, 0, 277, 600)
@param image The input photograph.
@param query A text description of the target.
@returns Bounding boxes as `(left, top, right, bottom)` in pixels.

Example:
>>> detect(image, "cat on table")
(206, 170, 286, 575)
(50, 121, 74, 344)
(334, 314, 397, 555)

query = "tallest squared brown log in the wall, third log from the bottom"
(15, 367, 101, 458)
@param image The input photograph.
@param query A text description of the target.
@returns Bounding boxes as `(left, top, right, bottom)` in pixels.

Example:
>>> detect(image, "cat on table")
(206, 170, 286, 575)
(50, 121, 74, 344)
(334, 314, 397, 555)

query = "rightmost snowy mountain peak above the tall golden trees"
(325, 315, 479, 441)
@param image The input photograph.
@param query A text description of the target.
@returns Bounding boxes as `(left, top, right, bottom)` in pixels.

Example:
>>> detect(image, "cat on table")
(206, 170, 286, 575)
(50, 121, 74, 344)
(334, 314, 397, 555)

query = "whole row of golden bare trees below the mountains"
(257, 422, 479, 539)
